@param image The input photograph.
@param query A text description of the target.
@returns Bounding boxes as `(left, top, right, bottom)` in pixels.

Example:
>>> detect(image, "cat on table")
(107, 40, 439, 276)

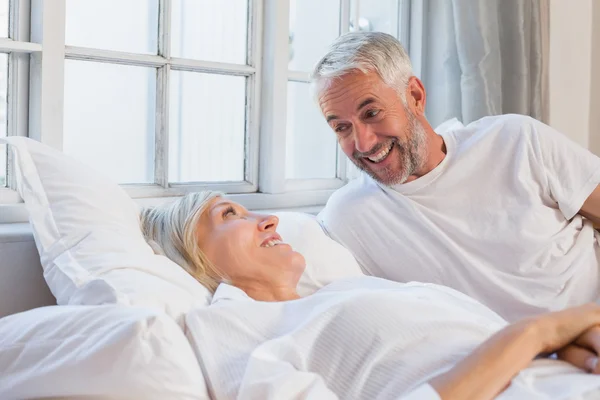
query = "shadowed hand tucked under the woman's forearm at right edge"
(556, 326, 600, 374)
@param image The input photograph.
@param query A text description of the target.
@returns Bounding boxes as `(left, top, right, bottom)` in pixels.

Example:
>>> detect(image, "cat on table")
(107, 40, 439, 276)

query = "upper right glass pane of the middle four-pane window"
(171, 0, 248, 64)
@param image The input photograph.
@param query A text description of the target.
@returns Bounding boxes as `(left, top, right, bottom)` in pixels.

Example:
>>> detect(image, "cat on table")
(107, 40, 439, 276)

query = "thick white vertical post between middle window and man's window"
(259, 0, 290, 193)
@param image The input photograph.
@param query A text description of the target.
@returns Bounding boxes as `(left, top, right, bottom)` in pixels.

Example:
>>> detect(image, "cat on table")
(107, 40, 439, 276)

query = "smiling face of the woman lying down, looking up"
(196, 197, 306, 288)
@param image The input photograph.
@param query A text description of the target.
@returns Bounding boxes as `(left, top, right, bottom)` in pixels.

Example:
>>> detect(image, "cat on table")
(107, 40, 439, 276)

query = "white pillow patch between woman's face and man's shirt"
(275, 212, 364, 296)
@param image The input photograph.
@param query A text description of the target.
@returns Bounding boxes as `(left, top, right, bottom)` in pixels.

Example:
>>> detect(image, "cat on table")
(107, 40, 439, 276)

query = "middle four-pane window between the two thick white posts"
(63, 0, 257, 192)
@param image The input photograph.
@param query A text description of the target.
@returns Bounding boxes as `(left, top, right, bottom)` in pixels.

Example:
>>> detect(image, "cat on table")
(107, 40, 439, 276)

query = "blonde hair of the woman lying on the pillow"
(140, 191, 223, 293)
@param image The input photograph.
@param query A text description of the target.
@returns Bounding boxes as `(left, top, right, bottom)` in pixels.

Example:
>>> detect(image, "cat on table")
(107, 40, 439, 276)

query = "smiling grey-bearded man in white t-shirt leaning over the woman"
(312, 33, 600, 320)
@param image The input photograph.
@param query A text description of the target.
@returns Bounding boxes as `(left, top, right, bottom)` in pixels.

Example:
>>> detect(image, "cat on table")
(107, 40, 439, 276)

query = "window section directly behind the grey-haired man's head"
(286, 0, 403, 179)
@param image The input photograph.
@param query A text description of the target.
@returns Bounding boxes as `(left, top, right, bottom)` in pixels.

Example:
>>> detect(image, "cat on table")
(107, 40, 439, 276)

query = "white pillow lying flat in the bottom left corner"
(0, 306, 209, 400)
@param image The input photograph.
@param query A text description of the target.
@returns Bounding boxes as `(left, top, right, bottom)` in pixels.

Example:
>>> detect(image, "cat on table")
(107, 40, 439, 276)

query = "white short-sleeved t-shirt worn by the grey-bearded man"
(319, 115, 600, 321)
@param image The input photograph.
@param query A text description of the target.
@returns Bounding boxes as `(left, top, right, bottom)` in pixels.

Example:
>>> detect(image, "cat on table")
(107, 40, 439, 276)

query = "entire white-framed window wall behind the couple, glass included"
(0, 0, 408, 222)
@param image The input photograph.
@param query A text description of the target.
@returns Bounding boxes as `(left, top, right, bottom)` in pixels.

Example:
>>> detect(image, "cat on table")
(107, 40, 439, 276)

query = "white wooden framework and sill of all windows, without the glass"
(0, 0, 412, 223)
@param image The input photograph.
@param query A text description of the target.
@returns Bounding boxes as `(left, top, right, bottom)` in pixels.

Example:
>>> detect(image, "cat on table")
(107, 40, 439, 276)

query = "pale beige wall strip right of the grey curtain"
(548, 0, 600, 154)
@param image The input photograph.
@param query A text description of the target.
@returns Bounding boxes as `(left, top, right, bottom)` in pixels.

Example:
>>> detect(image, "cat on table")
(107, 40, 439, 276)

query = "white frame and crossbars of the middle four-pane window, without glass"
(32, 0, 261, 198)
